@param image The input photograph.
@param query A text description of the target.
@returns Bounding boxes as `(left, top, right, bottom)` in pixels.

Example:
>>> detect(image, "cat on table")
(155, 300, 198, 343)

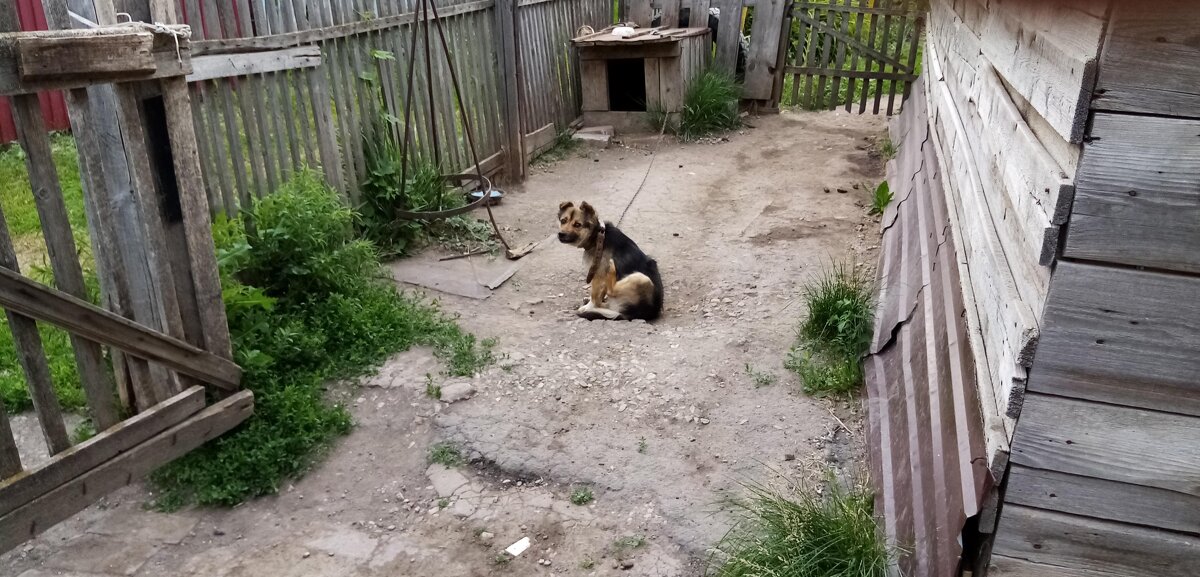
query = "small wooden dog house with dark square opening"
(571, 28, 712, 132)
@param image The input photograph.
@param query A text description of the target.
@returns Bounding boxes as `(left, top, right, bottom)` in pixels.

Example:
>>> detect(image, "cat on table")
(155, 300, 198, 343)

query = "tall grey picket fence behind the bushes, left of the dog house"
(180, 0, 611, 212)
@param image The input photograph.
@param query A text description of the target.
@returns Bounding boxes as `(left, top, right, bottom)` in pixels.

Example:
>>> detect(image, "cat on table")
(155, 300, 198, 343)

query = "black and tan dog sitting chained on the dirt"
(558, 202, 662, 320)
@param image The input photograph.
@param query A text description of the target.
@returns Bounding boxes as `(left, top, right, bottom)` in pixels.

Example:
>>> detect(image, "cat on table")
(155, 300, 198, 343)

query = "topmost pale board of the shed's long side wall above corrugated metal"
(979, 0, 1104, 143)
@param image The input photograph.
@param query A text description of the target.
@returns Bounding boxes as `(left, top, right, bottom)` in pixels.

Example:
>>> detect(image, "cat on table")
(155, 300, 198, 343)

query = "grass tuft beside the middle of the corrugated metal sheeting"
(784, 264, 875, 395)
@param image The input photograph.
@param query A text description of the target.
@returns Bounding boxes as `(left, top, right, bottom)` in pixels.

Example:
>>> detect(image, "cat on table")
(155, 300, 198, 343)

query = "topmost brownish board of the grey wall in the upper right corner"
(1092, 0, 1200, 118)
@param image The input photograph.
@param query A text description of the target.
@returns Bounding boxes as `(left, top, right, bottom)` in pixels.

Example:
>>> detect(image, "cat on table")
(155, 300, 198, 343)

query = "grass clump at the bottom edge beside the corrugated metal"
(707, 481, 895, 577)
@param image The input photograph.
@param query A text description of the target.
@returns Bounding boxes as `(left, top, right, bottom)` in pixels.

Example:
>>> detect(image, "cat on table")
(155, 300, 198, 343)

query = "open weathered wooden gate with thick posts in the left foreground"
(0, 0, 253, 552)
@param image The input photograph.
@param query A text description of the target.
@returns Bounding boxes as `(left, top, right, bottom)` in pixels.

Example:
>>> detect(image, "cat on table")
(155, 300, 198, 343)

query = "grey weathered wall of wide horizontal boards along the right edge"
(989, 0, 1200, 577)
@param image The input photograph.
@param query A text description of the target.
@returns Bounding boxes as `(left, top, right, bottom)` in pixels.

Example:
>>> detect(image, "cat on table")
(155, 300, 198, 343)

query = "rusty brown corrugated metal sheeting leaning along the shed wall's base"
(865, 77, 991, 577)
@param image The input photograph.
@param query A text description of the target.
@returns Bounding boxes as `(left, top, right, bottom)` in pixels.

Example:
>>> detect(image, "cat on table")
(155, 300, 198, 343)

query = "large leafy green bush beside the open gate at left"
(151, 173, 493, 509)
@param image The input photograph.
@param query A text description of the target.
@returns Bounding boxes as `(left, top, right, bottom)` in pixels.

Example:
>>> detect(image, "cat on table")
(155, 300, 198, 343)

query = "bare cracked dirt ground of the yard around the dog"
(0, 113, 884, 577)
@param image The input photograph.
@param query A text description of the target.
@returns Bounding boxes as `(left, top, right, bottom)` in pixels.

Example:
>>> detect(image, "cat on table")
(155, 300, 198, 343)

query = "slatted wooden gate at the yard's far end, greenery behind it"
(784, 0, 928, 114)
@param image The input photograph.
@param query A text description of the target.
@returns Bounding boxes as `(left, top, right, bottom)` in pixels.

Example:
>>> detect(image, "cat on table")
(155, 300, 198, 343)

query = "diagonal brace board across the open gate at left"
(0, 268, 241, 389)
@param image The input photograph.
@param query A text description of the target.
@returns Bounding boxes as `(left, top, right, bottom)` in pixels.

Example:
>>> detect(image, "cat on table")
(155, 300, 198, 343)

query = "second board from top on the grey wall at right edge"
(1063, 113, 1200, 272)
